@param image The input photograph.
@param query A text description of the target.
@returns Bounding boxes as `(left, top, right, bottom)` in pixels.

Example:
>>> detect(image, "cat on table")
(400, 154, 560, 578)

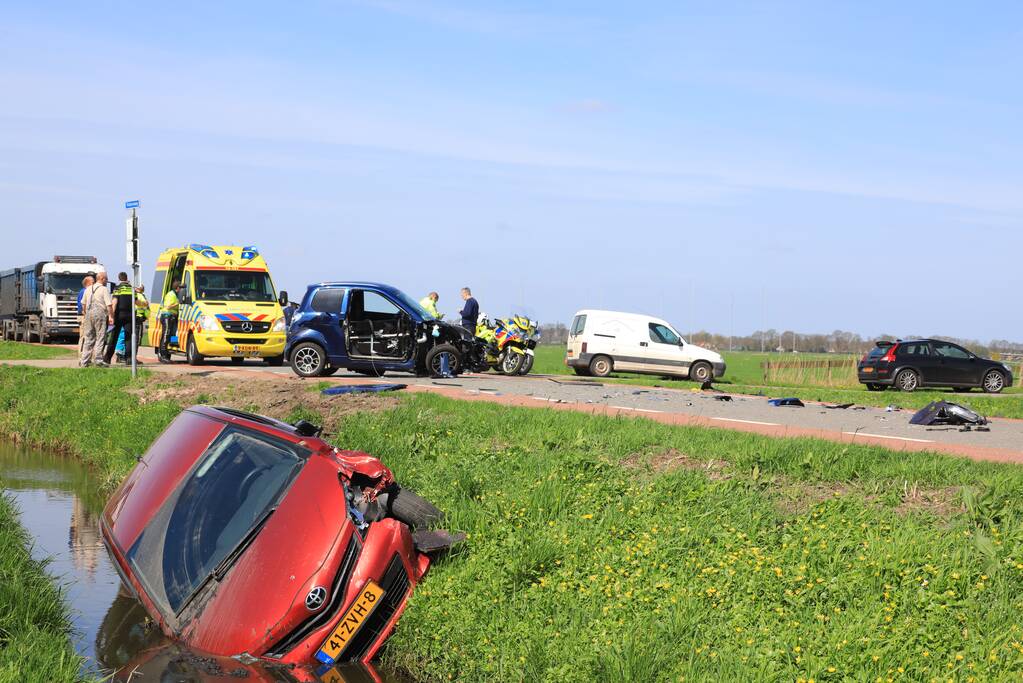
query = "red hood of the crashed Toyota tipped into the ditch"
(181, 454, 355, 656)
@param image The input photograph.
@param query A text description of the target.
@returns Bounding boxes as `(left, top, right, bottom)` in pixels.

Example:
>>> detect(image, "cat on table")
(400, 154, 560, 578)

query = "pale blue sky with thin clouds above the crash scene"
(0, 0, 1023, 340)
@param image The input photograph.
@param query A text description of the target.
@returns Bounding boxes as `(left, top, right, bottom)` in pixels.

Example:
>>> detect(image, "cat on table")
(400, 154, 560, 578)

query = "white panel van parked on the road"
(565, 310, 724, 382)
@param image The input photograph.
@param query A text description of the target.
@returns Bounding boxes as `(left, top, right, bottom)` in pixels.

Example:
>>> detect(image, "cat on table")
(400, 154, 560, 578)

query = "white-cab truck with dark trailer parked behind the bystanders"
(0, 256, 106, 344)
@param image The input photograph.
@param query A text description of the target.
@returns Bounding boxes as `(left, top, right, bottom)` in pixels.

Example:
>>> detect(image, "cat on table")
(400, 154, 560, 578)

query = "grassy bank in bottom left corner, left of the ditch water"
(0, 494, 82, 682)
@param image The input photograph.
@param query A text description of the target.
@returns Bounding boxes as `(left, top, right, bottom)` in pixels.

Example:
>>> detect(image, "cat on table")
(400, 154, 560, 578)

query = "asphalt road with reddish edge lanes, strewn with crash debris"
(10, 350, 1023, 464)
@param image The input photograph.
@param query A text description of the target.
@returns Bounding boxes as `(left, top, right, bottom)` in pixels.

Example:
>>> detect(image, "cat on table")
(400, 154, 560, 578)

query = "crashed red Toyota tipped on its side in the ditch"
(101, 406, 451, 672)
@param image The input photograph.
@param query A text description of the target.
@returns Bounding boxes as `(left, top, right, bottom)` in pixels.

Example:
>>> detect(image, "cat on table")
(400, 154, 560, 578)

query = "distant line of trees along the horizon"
(540, 322, 1023, 356)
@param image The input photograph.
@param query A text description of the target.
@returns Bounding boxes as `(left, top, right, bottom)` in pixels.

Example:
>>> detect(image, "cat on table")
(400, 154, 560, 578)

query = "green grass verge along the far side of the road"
(533, 346, 1023, 419)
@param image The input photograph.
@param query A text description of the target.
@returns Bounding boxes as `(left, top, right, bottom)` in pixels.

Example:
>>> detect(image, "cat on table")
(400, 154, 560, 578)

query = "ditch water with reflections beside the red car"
(0, 442, 403, 683)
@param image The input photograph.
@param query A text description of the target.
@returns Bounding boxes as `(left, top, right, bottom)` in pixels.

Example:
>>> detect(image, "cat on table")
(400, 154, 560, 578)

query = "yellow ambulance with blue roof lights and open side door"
(149, 244, 287, 365)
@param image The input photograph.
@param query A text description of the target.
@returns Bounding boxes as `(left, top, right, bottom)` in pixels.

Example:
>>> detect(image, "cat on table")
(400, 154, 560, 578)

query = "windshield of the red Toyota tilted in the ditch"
(128, 426, 309, 614)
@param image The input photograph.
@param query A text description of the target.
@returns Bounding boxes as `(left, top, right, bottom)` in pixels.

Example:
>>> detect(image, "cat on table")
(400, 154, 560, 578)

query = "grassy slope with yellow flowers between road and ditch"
(0, 361, 1023, 681)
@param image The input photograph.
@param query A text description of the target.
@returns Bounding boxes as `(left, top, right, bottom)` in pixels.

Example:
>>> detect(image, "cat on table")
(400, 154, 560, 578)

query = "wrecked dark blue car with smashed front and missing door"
(284, 282, 476, 377)
